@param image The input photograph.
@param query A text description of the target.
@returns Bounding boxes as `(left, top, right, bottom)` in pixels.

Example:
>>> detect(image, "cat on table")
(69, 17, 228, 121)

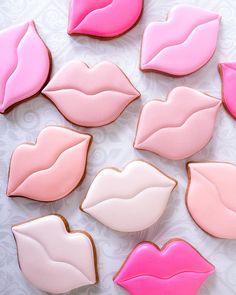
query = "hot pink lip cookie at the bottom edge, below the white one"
(114, 240, 214, 295)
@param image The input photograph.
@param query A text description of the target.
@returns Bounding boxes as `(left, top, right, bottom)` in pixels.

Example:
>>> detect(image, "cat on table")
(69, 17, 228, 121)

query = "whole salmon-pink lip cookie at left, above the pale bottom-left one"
(7, 126, 91, 202)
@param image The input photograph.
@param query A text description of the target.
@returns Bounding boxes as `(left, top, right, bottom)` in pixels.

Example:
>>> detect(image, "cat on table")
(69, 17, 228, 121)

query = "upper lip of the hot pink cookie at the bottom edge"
(114, 240, 215, 284)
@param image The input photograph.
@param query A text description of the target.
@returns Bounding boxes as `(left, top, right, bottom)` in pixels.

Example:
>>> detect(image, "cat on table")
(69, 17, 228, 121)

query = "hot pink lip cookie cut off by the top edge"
(68, 0, 143, 37)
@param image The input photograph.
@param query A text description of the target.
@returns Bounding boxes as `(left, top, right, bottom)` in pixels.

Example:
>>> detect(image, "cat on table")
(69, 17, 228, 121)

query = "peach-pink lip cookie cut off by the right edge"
(186, 162, 236, 239)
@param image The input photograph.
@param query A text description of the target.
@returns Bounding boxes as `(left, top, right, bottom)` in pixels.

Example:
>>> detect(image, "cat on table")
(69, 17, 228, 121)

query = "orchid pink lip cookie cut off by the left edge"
(0, 21, 50, 113)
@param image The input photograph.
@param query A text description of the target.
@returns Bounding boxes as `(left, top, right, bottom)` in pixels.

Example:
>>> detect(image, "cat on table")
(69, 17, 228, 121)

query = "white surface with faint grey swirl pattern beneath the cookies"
(0, 0, 236, 295)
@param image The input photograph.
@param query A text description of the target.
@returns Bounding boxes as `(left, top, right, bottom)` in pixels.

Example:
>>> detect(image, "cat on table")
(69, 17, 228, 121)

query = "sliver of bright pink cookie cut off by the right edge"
(219, 62, 236, 119)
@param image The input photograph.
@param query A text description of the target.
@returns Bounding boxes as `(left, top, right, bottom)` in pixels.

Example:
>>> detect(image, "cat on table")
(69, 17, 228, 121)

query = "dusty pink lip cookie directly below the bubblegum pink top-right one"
(134, 87, 221, 160)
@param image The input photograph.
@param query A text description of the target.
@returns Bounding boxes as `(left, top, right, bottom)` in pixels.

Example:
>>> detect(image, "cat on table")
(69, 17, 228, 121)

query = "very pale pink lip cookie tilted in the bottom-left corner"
(12, 215, 97, 294)
